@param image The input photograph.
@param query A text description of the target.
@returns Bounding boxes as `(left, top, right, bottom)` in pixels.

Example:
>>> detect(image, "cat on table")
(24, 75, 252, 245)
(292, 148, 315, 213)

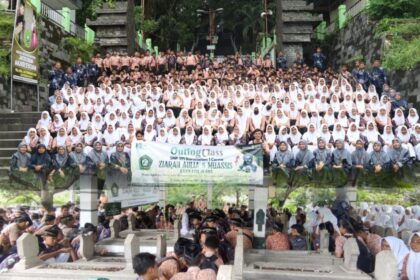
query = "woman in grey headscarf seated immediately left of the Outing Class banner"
(110, 141, 131, 187)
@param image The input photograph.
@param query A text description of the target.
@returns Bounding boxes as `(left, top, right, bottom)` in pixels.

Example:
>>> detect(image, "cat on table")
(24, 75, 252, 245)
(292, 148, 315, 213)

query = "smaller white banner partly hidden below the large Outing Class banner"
(107, 185, 159, 208)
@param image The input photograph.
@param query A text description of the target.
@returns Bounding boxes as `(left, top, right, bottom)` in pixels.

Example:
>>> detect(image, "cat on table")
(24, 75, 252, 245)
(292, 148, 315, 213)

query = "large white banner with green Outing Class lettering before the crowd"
(131, 142, 263, 186)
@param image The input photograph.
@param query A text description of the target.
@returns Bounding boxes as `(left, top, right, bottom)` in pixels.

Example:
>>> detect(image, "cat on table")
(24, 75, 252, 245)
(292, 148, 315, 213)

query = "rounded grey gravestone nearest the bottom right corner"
(375, 250, 398, 280)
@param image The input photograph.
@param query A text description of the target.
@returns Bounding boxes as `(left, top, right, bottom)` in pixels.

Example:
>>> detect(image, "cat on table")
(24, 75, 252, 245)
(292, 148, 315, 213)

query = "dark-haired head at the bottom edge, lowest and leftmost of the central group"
(133, 253, 159, 280)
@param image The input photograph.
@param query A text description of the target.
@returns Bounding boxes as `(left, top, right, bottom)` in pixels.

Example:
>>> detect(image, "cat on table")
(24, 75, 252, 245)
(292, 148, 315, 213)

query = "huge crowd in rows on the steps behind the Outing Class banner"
(11, 48, 420, 185)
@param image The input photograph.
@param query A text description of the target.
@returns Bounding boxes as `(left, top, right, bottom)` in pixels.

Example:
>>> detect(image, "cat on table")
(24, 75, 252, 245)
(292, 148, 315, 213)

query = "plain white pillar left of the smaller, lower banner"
(79, 174, 98, 226)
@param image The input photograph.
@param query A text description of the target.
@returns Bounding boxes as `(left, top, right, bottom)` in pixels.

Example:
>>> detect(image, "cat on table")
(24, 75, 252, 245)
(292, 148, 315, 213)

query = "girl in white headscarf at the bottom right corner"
(401, 232, 420, 280)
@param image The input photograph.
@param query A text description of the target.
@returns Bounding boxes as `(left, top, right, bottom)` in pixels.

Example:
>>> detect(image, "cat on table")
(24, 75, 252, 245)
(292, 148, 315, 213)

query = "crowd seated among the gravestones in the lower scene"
(0, 196, 420, 280)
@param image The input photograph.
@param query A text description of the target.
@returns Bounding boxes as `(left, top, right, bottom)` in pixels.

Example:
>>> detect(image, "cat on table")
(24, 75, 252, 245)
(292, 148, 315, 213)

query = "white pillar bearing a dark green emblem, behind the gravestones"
(253, 187, 268, 249)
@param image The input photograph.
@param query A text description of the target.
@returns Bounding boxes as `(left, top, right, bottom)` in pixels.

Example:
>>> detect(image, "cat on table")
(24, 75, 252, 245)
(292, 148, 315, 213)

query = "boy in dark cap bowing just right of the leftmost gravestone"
(38, 227, 77, 264)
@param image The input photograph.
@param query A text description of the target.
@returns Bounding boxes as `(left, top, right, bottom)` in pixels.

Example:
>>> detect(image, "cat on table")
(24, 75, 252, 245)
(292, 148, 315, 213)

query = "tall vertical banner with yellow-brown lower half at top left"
(12, 0, 39, 84)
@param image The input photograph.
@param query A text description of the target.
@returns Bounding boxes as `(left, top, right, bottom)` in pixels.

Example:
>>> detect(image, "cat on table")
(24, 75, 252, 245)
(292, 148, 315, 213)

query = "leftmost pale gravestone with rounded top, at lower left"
(12, 233, 43, 270)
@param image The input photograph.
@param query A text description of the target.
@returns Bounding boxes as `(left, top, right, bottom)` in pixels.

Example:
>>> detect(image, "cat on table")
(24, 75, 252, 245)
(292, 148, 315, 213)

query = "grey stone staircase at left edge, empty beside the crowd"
(0, 112, 41, 183)
